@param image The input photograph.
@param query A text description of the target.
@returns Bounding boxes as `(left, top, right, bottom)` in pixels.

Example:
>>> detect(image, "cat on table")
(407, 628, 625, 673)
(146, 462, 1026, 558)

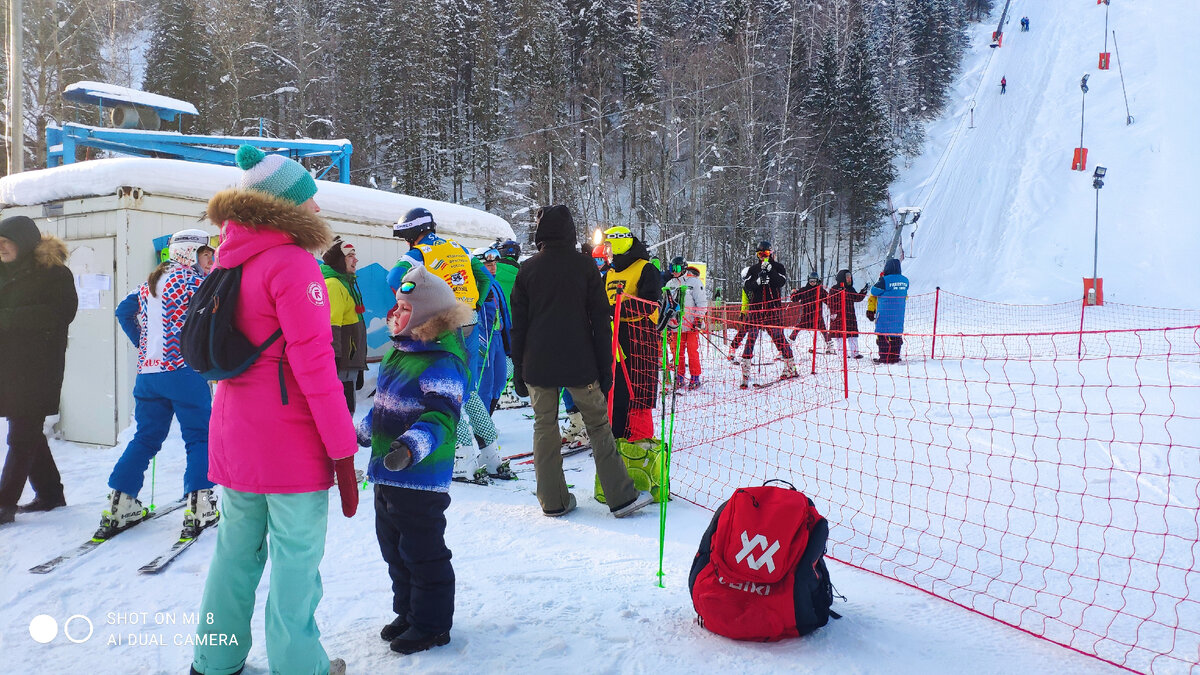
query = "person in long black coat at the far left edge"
(0, 216, 78, 524)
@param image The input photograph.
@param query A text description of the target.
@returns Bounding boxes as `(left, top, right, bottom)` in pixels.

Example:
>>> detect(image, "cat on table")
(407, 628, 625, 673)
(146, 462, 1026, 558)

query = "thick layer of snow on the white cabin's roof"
(0, 157, 514, 239)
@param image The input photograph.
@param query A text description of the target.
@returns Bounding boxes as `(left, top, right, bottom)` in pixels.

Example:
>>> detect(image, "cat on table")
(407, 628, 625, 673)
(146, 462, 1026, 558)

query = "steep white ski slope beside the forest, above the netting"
(883, 0, 1200, 307)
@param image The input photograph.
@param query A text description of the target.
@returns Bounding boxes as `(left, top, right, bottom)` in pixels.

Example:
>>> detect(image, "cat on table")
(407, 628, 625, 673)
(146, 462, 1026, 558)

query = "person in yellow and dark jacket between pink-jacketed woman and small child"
(320, 237, 367, 414)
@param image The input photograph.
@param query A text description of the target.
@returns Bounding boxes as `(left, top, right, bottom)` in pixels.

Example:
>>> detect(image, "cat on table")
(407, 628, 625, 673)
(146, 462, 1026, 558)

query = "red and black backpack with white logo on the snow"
(688, 485, 840, 641)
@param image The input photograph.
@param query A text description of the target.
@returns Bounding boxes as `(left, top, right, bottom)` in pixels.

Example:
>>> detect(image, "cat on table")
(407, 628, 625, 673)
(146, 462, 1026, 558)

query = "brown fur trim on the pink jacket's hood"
(206, 189, 334, 255)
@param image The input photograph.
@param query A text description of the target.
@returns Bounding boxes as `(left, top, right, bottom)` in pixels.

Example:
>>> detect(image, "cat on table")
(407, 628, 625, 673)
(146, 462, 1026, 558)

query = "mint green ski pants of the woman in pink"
(192, 488, 329, 675)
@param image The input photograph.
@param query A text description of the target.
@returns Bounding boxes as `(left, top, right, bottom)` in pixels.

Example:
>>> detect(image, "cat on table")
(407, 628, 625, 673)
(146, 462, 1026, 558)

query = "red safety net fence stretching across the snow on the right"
(619, 292, 1200, 673)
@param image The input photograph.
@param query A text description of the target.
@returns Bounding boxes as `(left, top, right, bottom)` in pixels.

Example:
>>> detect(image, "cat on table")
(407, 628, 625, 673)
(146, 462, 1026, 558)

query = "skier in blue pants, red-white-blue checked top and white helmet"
(104, 229, 220, 539)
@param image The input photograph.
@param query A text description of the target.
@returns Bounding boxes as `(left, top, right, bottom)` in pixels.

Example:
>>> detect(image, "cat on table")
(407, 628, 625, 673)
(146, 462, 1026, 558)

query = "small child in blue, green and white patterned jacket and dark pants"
(359, 265, 475, 653)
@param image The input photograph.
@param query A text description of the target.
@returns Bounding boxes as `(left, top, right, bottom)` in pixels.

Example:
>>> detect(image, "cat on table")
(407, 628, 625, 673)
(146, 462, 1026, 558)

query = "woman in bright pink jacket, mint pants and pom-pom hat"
(192, 145, 358, 675)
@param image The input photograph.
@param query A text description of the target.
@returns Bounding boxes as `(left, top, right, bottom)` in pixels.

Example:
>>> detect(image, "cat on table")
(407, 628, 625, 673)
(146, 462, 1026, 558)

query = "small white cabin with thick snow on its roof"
(0, 157, 514, 446)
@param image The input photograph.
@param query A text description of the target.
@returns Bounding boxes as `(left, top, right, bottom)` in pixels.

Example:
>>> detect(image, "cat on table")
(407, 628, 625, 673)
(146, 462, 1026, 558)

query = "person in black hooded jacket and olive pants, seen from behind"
(511, 205, 650, 516)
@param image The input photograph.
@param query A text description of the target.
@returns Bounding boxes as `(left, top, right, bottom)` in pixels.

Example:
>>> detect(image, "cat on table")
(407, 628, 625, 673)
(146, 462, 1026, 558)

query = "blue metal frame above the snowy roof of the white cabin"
(46, 123, 354, 184)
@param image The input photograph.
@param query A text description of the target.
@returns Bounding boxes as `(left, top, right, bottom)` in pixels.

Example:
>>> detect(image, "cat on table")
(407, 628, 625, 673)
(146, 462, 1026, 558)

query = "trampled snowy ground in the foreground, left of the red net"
(0, 389, 1116, 675)
